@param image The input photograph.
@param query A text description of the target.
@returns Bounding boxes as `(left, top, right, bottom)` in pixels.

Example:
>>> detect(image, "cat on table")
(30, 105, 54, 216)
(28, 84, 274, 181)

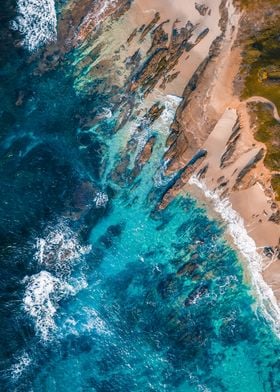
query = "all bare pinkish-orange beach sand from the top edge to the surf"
(74, 0, 280, 299)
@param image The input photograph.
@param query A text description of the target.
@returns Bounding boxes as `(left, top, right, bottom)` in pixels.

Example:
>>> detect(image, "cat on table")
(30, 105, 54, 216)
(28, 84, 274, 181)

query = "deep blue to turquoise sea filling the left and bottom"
(0, 1, 280, 392)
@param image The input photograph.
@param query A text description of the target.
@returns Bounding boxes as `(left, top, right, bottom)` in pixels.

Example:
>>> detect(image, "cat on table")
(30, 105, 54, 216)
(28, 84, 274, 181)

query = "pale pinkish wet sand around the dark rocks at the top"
(86, 0, 221, 96)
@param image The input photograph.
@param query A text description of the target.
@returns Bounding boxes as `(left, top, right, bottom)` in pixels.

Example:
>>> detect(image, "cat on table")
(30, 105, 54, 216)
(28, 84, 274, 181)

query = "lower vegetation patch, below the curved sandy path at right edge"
(255, 103, 280, 200)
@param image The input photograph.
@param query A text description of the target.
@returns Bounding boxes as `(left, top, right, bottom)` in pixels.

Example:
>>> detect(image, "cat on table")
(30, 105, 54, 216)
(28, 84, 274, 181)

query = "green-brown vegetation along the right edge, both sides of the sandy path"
(241, 11, 280, 200)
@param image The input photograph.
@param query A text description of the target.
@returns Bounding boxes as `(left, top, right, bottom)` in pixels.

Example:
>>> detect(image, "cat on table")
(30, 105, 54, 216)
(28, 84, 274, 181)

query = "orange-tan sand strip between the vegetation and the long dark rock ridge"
(159, 0, 280, 310)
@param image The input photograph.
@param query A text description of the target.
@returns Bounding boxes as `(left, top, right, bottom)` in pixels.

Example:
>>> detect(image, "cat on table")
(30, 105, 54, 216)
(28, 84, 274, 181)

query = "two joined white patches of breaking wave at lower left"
(23, 222, 91, 341)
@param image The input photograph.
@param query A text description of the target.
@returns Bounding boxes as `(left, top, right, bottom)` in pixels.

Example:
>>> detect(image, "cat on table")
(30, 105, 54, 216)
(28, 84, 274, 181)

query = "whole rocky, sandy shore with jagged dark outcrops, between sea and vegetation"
(8, 0, 280, 304)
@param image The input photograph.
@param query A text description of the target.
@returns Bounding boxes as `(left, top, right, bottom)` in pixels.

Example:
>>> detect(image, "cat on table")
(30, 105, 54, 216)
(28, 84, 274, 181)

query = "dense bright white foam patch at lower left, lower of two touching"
(23, 271, 75, 341)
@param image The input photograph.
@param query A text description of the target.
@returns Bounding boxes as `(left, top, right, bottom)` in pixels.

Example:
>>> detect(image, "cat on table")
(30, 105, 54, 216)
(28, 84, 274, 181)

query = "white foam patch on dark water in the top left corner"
(10, 0, 57, 52)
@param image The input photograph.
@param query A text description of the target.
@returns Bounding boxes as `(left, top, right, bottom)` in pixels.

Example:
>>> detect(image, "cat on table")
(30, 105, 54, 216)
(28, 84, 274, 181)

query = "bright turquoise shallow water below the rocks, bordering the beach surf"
(4, 97, 279, 392)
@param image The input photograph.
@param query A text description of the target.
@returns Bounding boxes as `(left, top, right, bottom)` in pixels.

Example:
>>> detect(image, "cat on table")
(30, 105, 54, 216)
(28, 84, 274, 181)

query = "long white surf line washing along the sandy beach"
(189, 176, 280, 335)
